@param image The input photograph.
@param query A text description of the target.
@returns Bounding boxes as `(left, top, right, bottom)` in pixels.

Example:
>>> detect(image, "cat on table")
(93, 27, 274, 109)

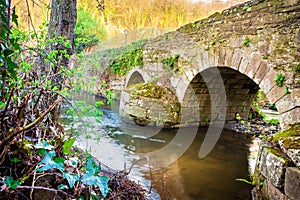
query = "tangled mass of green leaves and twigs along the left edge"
(0, 3, 108, 199)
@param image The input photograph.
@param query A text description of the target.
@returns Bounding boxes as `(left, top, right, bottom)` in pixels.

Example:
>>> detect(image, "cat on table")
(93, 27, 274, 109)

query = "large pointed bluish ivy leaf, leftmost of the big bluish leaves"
(36, 151, 64, 172)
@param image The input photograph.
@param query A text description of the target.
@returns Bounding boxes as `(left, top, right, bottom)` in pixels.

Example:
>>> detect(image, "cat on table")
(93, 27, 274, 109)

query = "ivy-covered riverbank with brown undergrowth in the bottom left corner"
(0, 141, 146, 200)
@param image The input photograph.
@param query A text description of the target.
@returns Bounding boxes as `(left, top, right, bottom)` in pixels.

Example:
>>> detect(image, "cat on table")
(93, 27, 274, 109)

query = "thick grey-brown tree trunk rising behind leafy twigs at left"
(40, 0, 77, 122)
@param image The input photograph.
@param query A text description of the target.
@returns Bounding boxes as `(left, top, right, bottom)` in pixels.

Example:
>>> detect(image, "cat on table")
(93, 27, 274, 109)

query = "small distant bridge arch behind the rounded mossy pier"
(125, 68, 149, 88)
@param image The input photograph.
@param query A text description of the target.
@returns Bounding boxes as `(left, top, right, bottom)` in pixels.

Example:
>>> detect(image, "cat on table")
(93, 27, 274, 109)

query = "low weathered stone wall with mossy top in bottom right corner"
(256, 136, 300, 200)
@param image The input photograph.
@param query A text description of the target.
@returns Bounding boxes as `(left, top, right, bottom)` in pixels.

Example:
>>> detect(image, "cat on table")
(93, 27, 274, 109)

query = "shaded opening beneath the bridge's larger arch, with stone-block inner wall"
(181, 67, 278, 126)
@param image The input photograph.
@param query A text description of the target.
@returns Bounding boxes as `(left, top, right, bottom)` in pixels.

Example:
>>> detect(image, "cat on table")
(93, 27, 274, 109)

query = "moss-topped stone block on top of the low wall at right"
(278, 136, 300, 167)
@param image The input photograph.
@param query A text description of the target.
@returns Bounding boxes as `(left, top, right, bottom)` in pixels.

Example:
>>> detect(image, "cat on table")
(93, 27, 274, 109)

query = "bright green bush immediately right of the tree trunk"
(75, 6, 106, 53)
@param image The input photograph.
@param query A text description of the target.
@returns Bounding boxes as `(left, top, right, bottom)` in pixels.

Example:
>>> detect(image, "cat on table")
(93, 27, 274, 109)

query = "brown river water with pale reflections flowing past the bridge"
(63, 96, 257, 200)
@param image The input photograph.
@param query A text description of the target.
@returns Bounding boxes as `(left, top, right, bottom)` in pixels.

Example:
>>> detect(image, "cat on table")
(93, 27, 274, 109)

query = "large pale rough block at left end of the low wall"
(259, 147, 290, 188)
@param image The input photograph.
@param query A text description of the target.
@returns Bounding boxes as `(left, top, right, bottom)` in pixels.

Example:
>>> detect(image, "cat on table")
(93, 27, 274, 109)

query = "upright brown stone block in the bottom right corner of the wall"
(284, 167, 300, 200)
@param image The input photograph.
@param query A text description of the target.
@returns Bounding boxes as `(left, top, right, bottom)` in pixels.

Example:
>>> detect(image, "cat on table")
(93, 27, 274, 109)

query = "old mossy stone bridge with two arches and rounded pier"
(115, 0, 300, 128)
